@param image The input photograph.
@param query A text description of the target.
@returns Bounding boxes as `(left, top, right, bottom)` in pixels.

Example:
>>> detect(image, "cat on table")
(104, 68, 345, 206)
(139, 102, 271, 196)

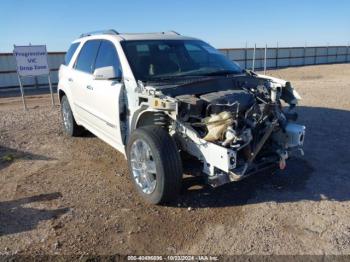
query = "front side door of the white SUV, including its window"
(86, 40, 124, 149)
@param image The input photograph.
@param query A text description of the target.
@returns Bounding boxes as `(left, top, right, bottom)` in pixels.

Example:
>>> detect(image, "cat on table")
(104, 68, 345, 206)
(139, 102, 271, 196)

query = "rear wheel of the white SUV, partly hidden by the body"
(61, 96, 84, 137)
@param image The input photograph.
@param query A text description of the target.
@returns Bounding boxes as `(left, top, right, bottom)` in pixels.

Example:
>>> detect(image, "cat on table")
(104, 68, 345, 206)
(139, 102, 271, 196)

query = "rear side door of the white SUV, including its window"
(68, 40, 101, 126)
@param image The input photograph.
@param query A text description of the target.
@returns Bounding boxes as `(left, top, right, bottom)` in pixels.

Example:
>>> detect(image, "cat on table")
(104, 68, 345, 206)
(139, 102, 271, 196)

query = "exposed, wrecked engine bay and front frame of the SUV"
(138, 72, 305, 186)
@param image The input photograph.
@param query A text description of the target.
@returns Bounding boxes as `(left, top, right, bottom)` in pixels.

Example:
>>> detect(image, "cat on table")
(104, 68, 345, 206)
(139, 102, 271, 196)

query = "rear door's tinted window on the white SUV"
(75, 40, 101, 74)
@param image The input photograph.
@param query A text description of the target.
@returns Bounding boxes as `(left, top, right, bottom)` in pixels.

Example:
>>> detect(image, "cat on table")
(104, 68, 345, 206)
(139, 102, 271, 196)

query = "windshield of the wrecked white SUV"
(122, 40, 242, 81)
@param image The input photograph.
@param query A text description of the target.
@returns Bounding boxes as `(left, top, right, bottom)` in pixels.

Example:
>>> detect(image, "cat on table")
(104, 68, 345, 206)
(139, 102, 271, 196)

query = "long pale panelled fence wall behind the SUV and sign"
(0, 46, 350, 89)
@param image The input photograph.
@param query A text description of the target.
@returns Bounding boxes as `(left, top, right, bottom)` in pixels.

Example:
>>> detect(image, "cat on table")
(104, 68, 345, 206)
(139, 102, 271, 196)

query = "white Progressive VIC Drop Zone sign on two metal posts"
(13, 44, 55, 110)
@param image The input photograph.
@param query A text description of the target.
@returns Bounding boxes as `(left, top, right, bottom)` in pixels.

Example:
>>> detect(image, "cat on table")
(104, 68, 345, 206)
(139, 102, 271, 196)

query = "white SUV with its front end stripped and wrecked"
(58, 30, 305, 204)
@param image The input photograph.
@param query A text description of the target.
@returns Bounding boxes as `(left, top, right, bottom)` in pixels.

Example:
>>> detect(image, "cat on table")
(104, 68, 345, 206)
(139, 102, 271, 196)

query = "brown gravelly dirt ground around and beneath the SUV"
(0, 64, 350, 255)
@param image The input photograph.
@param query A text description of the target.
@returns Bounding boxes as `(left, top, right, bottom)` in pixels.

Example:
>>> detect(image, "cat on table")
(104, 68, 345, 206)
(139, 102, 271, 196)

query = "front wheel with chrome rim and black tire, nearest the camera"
(126, 126, 182, 204)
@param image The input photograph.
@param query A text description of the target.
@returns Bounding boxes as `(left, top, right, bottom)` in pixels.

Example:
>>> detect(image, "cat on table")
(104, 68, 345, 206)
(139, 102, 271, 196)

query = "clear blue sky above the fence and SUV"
(0, 0, 350, 53)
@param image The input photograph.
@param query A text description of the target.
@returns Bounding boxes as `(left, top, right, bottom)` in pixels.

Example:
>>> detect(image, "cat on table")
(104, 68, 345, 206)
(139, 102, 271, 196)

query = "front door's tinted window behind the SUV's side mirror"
(95, 41, 121, 77)
